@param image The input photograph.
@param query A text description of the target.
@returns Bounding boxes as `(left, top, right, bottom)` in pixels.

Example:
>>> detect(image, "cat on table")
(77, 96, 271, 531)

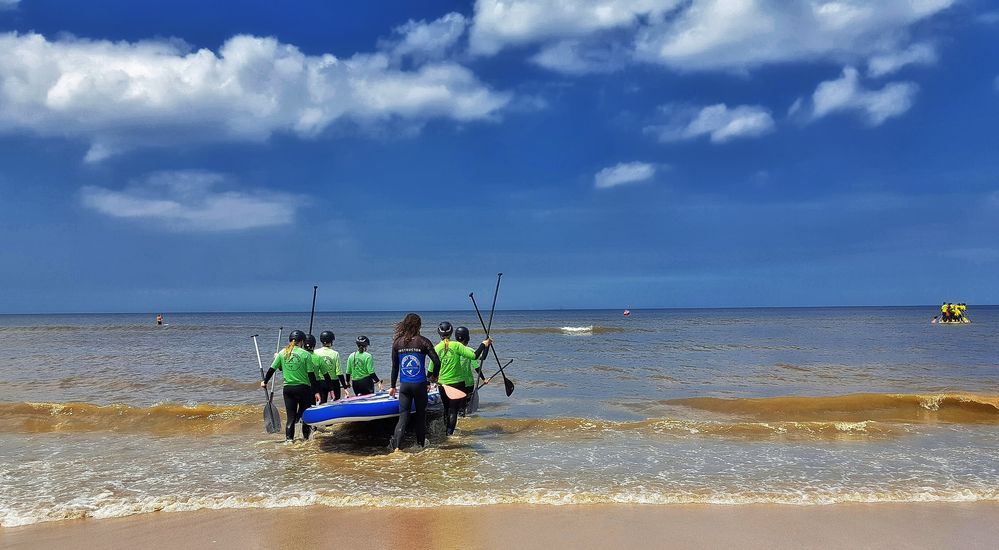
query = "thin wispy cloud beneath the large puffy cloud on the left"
(81, 171, 301, 232)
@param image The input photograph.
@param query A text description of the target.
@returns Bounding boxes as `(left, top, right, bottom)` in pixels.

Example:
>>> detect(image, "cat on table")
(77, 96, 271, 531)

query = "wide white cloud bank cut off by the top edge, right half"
(470, 0, 955, 70)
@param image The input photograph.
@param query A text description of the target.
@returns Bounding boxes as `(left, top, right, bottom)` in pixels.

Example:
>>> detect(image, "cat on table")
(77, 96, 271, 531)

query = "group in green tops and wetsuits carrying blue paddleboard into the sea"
(260, 313, 492, 451)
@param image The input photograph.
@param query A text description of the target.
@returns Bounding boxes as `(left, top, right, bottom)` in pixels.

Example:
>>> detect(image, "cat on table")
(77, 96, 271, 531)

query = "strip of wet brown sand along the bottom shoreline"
(0, 503, 999, 550)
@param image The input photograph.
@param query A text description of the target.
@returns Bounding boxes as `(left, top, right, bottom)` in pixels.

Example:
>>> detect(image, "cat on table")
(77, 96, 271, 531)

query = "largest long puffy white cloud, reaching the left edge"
(0, 33, 511, 161)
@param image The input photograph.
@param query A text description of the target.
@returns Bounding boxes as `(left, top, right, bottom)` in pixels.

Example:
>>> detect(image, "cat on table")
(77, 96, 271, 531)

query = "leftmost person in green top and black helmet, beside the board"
(260, 330, 319, 441)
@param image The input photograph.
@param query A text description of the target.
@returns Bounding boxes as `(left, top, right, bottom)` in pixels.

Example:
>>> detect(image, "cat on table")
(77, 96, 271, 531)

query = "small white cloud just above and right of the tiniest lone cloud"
(645, 103, 774, 143)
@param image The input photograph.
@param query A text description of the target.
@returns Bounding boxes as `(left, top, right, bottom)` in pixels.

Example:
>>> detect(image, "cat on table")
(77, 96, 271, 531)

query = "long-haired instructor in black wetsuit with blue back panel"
(389, 313, 441, 451)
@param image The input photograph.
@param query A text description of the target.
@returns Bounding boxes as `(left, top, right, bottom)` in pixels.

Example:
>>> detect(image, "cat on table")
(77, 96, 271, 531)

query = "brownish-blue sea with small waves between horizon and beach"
(0, 307, 999, 527)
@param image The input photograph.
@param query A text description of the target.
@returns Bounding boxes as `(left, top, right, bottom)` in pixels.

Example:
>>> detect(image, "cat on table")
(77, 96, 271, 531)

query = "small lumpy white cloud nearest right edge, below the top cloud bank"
(812, 67, 919, 126)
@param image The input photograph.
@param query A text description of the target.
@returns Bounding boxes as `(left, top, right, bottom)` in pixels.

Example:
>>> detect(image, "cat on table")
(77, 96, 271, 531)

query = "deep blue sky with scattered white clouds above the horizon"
(0, 0, 999, 313)
